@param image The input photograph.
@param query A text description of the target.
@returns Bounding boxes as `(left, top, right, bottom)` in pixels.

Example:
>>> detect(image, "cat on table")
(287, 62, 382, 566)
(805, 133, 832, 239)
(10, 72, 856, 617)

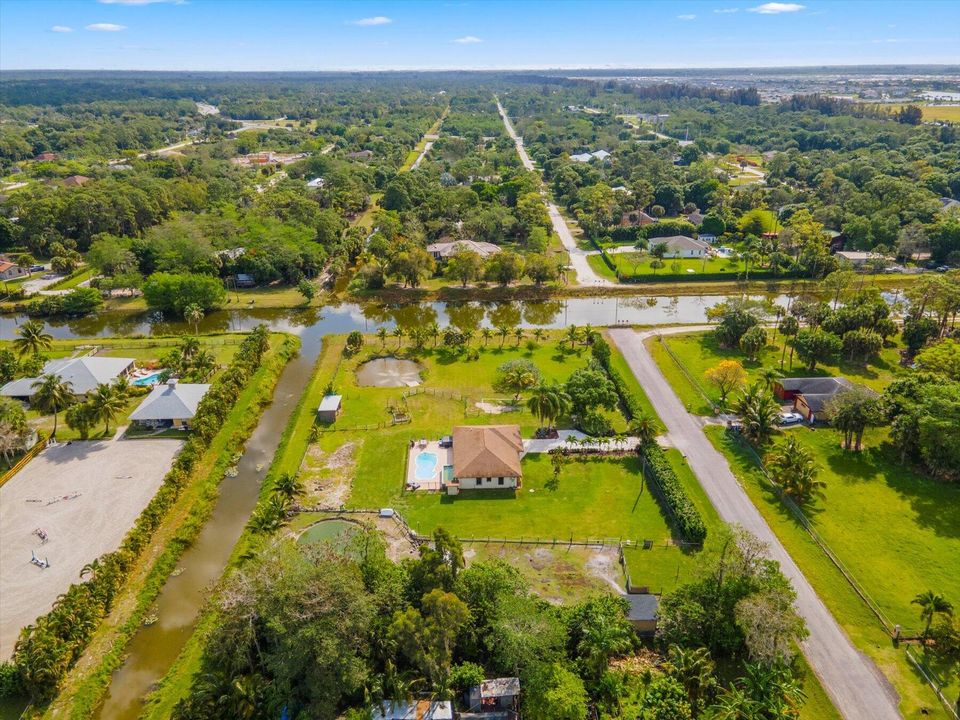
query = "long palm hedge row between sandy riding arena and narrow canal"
(0, 325, 270, 702)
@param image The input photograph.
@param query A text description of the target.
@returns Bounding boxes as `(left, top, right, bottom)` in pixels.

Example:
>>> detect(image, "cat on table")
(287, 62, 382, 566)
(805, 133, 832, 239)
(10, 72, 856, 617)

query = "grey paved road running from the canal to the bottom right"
(610, 327, 901, 720)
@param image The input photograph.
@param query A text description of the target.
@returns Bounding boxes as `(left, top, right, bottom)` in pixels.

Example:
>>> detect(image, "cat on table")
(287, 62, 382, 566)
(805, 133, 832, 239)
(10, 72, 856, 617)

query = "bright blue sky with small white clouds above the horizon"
(0, 0, 960, 70)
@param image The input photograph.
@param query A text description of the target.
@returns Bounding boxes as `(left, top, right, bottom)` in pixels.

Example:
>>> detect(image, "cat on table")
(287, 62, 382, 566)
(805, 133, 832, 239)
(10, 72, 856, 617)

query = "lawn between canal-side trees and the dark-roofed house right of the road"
(647, 328, 903, 415)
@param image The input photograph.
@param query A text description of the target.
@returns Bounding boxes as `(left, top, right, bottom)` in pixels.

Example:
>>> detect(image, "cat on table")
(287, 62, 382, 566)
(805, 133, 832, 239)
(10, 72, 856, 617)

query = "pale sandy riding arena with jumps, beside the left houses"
(0, 439, 182, 660)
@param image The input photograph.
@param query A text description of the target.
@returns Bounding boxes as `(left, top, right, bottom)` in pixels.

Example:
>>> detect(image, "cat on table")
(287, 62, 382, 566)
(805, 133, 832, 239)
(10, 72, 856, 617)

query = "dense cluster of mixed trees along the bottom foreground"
(174, 529, 805, 720)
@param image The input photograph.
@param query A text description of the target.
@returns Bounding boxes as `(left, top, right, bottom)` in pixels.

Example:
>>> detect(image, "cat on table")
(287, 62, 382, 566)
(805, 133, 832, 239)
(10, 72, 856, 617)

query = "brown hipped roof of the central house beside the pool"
(453, 425, 523, 478)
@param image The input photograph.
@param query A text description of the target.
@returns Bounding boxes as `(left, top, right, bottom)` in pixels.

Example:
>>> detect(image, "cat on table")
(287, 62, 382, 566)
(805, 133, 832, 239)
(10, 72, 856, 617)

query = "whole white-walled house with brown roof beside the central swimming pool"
(444, 425, 523, 495)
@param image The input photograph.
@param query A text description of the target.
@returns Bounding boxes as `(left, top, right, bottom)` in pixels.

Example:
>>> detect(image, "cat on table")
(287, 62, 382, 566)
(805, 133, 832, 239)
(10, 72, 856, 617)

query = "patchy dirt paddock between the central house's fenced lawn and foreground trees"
(464, 543, 624, 605)
